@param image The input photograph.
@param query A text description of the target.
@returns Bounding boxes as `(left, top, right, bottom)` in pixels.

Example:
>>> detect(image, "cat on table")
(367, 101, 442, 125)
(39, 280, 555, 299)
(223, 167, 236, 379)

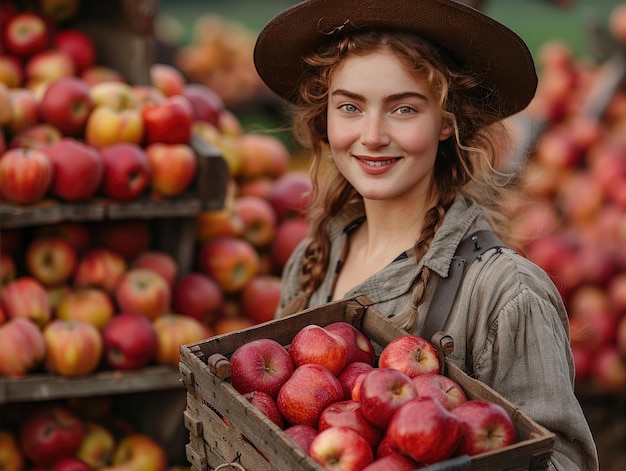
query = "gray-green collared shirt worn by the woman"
(277, 196, 598, 471)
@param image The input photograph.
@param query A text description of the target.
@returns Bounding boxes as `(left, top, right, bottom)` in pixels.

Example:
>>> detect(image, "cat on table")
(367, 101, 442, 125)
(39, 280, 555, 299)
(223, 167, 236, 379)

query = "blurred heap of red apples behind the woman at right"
(511, 5, 626, 393)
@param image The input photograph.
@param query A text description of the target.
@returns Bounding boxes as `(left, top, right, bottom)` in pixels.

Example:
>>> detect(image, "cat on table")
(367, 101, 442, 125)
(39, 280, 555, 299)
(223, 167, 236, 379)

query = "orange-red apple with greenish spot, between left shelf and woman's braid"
(197, 236, 260, 293)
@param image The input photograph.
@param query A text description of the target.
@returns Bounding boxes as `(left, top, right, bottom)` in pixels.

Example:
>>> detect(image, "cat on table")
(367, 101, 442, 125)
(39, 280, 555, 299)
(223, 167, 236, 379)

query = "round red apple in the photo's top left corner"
(2, 11, 51, 57)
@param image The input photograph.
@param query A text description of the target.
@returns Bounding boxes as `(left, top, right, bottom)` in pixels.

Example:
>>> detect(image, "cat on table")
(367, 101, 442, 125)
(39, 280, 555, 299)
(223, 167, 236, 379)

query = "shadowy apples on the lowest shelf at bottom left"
(0, 397, 175, 471)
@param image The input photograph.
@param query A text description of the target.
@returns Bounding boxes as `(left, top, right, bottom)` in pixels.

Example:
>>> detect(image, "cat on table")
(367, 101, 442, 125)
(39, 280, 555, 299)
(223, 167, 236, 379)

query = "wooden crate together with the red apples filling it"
(179, 297, 554, 471)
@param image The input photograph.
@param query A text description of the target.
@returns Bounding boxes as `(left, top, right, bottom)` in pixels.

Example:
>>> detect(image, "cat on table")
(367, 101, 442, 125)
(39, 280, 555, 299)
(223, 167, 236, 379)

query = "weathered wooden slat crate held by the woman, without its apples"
(179, 297, 555, 471)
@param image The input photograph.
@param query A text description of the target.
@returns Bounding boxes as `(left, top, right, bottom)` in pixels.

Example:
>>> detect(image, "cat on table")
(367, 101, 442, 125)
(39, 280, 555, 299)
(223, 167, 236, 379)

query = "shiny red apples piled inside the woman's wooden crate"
(227, 321, 516, 471)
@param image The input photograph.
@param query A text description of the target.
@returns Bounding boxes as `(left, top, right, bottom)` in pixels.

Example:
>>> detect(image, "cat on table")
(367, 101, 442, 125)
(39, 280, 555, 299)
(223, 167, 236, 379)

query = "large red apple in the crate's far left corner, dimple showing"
(230, 338, 294, 399)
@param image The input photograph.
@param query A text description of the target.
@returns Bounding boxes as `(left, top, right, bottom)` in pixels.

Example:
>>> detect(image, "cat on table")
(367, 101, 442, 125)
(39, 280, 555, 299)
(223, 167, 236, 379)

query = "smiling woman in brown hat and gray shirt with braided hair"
(255, 0, 598, 471)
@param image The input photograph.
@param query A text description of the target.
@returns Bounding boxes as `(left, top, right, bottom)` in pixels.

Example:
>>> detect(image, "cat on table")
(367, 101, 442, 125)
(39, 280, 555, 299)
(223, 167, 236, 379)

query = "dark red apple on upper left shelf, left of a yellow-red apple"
(39, 76, 94, 136)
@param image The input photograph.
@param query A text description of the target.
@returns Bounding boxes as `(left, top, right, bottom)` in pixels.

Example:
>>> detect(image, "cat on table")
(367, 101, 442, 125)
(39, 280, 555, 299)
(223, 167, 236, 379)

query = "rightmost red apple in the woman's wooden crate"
(452, 399, 515, 456)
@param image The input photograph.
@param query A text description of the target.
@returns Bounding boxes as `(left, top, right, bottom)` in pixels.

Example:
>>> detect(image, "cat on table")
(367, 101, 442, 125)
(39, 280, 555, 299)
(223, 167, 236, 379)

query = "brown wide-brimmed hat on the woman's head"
(254, 0, 537, 118)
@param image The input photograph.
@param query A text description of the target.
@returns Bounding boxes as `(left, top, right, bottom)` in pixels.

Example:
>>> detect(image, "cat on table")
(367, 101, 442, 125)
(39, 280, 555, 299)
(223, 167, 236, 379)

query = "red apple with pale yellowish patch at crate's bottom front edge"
(310, 427, 374, 471)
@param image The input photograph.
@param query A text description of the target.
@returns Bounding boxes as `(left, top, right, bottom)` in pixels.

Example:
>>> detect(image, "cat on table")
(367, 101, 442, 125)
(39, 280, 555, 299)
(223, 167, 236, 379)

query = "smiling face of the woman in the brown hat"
(328, 51, 452, 205)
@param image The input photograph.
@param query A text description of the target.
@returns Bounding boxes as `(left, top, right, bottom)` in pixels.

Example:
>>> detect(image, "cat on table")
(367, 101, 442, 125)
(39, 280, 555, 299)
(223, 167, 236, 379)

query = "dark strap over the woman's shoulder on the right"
(421, 230, 506, 340)
